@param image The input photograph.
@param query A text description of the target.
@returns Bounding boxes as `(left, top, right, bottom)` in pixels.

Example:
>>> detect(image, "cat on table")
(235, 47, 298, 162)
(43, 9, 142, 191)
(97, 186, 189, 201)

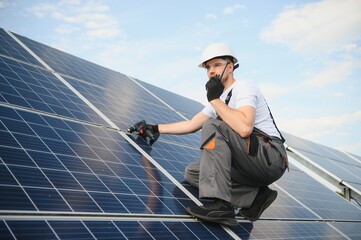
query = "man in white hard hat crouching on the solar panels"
(131, 43, 288, 226)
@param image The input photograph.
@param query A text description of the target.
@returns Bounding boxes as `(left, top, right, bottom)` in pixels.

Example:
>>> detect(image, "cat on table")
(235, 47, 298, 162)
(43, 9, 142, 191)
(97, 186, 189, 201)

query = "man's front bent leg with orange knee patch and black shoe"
(185, 120, 238, 226)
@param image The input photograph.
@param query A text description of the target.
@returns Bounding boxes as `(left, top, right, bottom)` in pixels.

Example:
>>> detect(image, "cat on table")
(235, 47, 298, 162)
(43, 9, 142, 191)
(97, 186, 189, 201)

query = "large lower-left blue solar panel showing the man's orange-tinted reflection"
(0, 106, 198, 217)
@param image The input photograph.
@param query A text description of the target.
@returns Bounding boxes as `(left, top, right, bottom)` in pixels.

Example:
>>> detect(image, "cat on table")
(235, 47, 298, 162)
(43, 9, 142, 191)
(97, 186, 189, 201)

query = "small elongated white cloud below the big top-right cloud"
(304, 62, 355, 87)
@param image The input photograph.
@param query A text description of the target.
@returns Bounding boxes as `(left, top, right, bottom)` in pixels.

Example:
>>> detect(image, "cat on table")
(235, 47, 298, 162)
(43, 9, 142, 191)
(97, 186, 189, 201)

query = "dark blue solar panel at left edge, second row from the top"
(0, 56, 106, 125)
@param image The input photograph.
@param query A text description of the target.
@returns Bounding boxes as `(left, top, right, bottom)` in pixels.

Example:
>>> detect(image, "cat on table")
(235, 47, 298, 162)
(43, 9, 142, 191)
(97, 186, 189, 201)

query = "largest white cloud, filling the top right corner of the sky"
(261, 0, 361, 53)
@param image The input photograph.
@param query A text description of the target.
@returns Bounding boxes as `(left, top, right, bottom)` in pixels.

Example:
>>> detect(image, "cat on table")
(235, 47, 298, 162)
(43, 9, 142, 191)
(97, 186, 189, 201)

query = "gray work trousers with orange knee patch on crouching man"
(185, 119, 288, 208)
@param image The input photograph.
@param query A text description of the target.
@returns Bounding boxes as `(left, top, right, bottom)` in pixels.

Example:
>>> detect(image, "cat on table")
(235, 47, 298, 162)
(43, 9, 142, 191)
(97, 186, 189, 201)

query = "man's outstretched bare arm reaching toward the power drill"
(158, 112, 210, 134)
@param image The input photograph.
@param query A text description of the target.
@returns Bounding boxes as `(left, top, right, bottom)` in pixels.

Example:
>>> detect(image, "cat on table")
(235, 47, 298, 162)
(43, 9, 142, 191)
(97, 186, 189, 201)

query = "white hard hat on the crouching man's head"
(198, 43, 238, 68)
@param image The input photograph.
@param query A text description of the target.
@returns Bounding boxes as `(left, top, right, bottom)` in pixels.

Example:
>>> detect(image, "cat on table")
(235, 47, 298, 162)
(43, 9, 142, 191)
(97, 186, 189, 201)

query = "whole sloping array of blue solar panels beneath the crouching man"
(0, 29, 361, 239)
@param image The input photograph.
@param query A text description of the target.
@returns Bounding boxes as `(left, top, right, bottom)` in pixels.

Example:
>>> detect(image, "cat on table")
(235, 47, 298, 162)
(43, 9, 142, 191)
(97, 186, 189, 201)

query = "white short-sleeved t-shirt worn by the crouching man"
(202, 81, 281, 138)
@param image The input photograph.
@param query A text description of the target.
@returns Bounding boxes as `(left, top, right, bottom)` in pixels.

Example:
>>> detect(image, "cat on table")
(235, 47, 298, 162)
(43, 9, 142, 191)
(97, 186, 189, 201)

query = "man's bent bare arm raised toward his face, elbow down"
(210, 99, 256, 137)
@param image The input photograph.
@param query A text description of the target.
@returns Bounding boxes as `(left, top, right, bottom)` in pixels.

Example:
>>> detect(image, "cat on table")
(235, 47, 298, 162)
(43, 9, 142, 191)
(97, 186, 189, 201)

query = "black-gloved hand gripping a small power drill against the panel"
(127, 120, 160, 145)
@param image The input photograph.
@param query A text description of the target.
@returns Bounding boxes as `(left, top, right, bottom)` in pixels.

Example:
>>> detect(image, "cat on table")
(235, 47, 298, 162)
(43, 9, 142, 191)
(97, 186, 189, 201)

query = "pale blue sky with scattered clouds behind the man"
(0, 0, 361, 156)
